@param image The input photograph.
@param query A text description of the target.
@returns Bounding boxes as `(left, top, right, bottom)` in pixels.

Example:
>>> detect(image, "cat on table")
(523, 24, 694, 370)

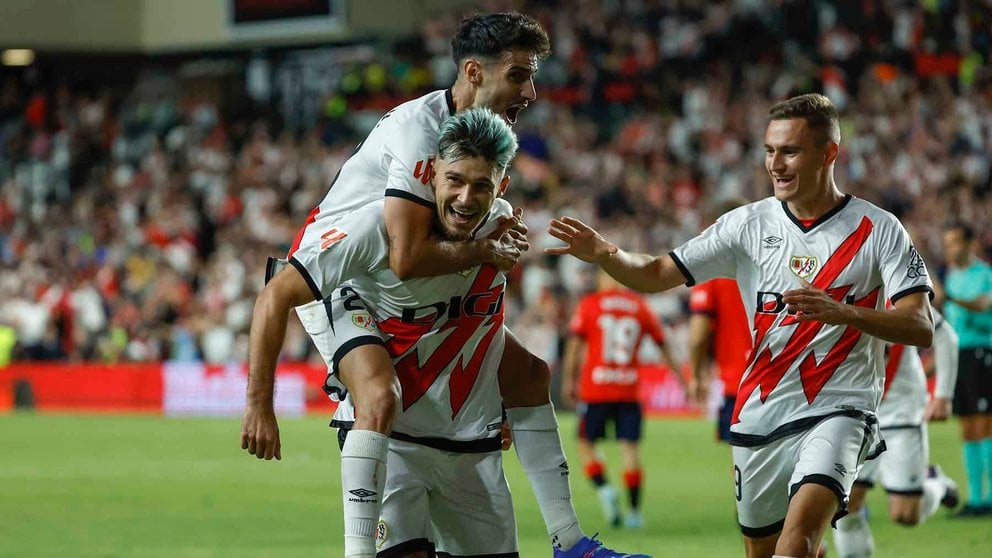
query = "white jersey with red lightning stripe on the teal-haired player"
(290, 198, 512, 442)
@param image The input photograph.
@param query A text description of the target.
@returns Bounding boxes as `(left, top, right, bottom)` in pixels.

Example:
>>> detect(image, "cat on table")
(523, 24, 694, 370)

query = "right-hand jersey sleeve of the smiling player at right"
(875, 216, 933, 303)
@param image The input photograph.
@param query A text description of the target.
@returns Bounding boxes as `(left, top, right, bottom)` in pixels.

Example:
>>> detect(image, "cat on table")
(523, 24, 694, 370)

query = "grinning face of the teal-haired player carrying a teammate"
(434, 157, 509, 240)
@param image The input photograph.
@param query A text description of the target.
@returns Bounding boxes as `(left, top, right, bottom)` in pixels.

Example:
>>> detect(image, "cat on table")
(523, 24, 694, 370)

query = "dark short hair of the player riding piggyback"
(451, 12, 551, 66)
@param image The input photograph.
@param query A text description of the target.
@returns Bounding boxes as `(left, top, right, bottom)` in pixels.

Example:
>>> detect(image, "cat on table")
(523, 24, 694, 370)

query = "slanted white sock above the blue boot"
(506, 403, 585, 550)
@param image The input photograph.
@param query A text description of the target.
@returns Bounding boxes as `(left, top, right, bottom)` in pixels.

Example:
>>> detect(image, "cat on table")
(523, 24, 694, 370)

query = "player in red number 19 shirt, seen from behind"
(562, 271, 681, 528)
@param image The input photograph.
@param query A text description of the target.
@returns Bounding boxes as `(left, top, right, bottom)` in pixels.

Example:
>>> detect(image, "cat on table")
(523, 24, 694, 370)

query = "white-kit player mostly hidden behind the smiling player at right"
(834, 312, 958, 558)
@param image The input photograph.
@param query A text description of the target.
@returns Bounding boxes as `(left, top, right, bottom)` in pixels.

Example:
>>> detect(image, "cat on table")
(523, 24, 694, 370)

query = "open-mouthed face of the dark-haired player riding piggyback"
(472, 50, 537, 124)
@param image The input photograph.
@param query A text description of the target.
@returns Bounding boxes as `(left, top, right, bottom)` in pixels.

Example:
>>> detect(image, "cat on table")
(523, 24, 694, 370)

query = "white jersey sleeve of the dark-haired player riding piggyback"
(382, 117, 438, 209)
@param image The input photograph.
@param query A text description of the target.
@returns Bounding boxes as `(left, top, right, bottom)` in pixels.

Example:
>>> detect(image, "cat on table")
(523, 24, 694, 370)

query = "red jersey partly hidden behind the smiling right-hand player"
(689, 279, 751, 397)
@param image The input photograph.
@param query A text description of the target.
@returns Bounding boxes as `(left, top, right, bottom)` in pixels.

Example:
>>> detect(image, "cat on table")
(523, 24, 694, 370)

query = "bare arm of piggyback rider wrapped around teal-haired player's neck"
(385, 196, 529, 280)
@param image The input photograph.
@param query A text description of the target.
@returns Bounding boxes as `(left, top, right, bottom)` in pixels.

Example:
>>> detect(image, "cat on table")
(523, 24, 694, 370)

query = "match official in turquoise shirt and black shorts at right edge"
(944, 223, 992, 517)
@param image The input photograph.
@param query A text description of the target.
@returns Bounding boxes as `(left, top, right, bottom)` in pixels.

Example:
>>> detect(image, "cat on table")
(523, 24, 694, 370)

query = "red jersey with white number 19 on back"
(569, 289, 665, 403)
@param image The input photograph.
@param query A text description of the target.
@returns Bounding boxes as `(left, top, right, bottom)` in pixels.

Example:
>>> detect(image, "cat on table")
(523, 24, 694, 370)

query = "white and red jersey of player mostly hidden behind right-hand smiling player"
(878, 310, 958, 428)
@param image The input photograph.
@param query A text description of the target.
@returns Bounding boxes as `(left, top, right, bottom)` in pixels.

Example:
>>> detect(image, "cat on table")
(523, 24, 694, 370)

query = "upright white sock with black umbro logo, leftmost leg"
(341, 430, 389, 558)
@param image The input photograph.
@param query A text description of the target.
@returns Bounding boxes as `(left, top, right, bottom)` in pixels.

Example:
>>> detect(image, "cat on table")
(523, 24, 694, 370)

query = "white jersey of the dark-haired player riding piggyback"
(289, 90, 455, 256)
